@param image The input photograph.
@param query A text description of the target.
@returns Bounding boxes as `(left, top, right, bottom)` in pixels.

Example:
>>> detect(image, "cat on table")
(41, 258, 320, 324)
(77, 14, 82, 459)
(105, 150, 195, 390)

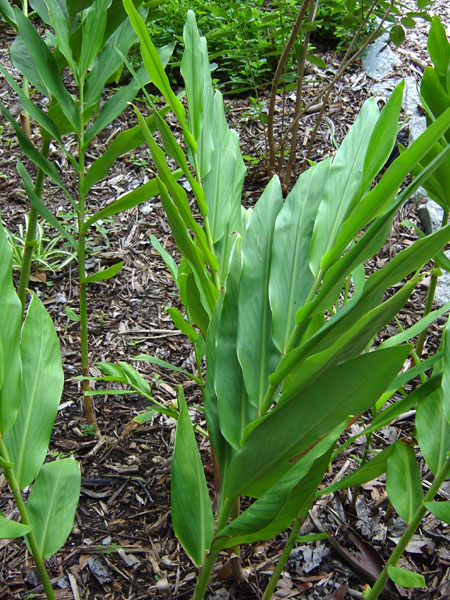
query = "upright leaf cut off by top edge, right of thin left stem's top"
(78, 0, 111, 76)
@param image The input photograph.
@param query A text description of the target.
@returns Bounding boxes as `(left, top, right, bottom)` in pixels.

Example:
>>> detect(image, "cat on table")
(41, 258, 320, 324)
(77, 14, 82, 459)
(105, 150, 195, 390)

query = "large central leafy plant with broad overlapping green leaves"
(109, 8, 450, 598)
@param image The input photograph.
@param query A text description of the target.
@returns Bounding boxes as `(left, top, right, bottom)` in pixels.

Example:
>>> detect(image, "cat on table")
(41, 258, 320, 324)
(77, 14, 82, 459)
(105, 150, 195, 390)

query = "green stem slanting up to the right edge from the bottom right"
(366, 454, 450, 600)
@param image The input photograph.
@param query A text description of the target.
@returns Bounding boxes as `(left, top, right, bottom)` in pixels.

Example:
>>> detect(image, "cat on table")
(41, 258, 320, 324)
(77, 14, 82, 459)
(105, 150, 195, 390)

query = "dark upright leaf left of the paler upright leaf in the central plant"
(214, 234, 256, 450)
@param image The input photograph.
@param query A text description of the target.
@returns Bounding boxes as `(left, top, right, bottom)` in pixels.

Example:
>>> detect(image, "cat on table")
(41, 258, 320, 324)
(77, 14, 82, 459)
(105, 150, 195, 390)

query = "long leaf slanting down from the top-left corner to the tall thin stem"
(14, 7, 79, 131)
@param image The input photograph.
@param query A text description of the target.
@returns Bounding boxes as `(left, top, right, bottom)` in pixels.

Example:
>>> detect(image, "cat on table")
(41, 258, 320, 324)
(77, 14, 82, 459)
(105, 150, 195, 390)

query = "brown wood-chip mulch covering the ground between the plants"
(0, 0, 450, 600)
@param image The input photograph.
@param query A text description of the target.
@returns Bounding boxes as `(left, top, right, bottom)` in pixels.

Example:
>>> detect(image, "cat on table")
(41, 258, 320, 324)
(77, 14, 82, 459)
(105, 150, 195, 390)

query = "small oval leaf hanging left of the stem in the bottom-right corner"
(386, 442, 423, 523)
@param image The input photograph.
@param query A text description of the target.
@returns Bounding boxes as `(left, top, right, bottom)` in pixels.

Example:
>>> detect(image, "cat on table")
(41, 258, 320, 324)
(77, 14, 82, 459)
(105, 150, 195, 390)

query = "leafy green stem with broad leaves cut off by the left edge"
(0, 221, 81, 599)
